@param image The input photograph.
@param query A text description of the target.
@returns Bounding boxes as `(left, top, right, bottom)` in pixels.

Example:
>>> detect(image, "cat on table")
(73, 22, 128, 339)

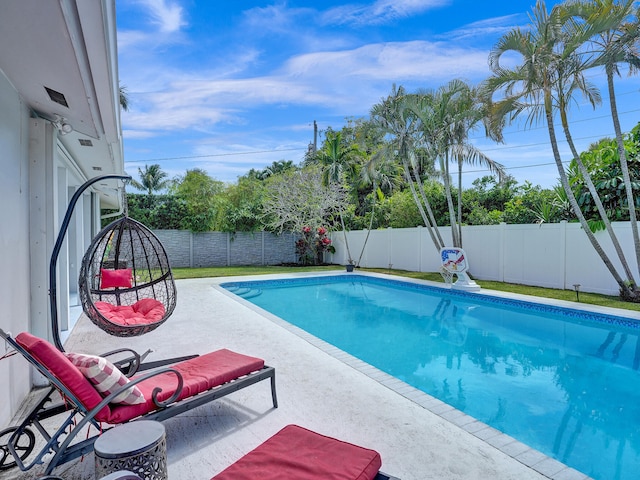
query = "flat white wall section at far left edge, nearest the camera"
(0, 72, 31, 425)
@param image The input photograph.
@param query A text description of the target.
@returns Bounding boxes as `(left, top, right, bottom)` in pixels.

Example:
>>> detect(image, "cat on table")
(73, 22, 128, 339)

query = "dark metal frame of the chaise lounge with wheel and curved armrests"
(0, 329, 278, 475)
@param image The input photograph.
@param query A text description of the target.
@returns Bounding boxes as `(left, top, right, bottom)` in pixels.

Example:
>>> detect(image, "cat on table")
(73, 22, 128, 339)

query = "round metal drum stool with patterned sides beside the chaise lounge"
(94, 420, 167, 480)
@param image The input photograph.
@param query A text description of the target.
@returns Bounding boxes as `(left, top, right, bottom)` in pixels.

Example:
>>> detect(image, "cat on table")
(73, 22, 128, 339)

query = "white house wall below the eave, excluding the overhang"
(0, 85, 94, 428)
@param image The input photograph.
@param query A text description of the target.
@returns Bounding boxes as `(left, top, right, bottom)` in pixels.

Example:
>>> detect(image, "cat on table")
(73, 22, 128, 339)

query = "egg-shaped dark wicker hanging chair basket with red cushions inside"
(79, 216, 176, 337)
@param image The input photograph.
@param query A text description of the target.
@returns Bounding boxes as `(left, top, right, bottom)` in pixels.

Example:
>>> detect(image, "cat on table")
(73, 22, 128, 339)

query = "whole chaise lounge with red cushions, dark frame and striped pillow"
(0, 329, 278, 475)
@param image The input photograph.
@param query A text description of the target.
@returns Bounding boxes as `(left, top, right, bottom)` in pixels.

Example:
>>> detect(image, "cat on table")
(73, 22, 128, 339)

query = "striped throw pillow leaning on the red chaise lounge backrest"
(65, 353, 145, 405)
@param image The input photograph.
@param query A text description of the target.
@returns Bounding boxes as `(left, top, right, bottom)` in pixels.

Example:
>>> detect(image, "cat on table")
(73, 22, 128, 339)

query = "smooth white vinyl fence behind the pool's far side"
(327, 222, 640, 295)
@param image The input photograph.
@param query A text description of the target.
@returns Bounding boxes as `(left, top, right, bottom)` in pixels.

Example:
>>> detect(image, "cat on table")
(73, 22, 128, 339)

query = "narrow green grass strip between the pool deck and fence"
(173, 265, 640, 311)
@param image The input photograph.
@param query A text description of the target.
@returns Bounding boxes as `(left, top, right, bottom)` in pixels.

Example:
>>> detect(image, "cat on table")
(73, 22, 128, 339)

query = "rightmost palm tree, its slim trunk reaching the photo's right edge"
(562, 0, 640, 278)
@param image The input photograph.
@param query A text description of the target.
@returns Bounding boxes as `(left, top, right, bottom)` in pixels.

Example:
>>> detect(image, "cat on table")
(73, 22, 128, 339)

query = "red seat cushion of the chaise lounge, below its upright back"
(107, 349, 264, 424)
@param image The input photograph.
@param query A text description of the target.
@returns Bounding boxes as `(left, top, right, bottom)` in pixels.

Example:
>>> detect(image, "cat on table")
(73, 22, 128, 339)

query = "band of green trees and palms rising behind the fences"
(121, 0, 640, 299)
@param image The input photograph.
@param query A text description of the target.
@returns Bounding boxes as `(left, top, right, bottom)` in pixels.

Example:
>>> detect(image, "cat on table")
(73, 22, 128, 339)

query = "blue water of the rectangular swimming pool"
(222, 275, 640, 480)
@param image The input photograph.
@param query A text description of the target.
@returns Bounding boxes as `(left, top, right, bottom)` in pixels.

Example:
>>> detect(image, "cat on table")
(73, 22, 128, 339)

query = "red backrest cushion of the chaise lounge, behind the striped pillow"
(16, 332, 111, 421)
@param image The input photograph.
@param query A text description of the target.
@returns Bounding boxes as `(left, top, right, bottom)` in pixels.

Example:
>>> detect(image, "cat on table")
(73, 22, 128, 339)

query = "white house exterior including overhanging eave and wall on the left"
(0, 0, 124, 429)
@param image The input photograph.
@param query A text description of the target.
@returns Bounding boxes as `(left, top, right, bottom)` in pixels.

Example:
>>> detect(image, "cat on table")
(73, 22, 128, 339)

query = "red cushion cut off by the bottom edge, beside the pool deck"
(212, 425, 382, 480)
